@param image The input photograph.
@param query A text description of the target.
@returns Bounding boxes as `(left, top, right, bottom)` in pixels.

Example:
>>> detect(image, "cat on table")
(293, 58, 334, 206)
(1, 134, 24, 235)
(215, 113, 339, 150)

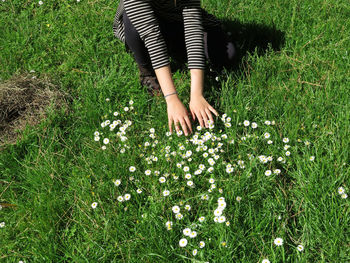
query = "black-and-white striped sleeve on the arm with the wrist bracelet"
(124, 0, 170, 69)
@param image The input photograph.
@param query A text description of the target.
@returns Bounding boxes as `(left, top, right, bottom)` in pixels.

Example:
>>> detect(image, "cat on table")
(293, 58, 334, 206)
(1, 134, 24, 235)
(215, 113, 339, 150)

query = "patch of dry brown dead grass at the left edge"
(0, 73, 68, 148)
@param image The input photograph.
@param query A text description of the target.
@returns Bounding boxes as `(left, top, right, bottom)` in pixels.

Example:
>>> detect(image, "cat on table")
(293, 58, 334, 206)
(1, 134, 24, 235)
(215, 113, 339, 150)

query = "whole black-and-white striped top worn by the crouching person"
(113, 0, 220, 69)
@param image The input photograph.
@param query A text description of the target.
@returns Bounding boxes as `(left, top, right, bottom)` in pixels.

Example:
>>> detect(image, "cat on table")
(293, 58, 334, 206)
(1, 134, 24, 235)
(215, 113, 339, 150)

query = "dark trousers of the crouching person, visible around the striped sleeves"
(123, 11, 236, 68)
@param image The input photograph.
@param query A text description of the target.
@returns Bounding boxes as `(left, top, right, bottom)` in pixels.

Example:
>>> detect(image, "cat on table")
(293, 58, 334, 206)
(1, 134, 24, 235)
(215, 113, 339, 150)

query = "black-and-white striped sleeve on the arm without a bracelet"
(182, 0, 205, 69)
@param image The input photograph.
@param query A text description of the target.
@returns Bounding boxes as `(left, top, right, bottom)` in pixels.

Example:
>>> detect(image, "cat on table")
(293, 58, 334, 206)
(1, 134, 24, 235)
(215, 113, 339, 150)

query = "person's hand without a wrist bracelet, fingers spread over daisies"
(190, 95, 219, 128)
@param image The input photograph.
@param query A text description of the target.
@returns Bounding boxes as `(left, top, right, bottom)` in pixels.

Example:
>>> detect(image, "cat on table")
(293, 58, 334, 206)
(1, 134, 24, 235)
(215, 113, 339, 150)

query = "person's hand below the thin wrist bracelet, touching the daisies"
(166, 94, 192, 136)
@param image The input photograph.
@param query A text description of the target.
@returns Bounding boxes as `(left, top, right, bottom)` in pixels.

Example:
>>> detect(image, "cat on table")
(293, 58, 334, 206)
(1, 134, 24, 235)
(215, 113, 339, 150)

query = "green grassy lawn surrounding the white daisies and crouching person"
(0, 0, 350, 262)
